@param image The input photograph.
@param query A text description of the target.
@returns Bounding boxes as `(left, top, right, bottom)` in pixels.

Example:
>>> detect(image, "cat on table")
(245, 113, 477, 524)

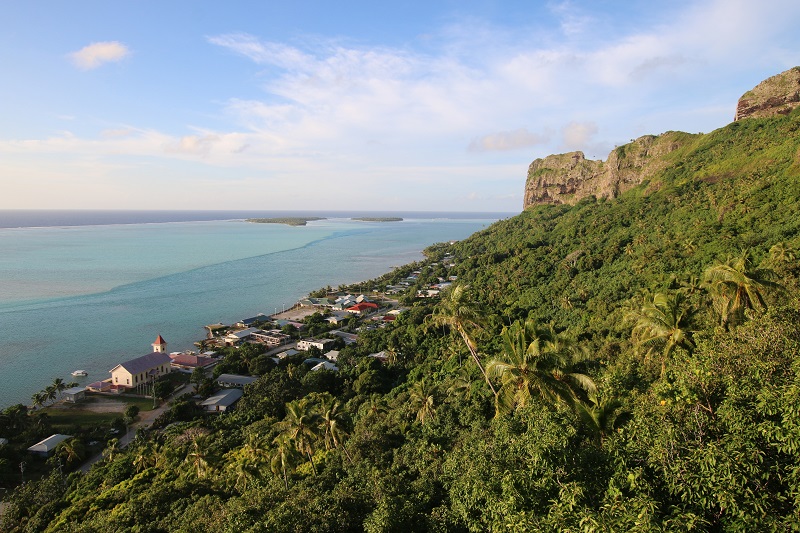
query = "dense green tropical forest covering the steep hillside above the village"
(3, 107, 800, 532)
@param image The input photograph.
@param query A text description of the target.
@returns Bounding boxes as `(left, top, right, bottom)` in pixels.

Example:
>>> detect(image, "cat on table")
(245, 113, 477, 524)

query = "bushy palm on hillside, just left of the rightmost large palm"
(627, 292, 694, 376)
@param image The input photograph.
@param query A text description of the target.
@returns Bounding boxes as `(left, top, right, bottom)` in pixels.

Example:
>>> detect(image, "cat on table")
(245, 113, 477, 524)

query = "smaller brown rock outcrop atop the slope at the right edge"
(733, 67, 800, 122)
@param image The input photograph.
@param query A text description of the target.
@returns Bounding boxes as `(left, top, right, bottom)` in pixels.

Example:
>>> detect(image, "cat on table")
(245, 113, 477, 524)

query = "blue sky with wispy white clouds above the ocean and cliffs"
(0, 0, 800, 212)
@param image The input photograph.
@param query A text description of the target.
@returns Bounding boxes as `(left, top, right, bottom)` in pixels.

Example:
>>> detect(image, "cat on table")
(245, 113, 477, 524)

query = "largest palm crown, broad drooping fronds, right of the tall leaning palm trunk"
(487, 320, 595, 415)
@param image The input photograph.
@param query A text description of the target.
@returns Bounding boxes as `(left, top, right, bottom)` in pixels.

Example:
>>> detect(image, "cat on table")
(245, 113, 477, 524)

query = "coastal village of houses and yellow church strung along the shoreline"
(15, 254, 456, 464)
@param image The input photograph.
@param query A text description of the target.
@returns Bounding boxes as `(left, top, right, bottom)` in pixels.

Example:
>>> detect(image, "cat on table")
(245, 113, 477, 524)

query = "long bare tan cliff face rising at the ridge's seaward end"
(523, 132, 690, 208)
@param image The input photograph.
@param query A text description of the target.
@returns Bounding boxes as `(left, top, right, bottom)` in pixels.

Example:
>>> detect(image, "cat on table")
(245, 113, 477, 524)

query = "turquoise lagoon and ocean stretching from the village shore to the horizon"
(0, 211, 512, 408)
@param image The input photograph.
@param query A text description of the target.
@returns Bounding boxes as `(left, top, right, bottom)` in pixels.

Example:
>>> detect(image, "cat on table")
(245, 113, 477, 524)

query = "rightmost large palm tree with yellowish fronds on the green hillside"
(704, 250, 782, 326)
